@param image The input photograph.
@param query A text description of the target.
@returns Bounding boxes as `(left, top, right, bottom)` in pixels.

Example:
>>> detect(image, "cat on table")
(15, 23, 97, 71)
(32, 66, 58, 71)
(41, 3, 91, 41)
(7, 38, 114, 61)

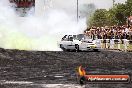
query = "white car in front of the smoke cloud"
(59, 34, 99, 51)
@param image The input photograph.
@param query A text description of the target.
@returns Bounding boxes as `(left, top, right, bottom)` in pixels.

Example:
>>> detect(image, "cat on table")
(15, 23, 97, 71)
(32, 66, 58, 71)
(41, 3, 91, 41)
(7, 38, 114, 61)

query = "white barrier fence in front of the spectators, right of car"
(97, 39, 132, 51)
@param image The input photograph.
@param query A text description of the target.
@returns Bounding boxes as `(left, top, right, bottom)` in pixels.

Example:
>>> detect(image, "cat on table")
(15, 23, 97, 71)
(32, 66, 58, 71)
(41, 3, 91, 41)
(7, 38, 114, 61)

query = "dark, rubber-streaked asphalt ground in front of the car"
(0, 49, 132, 88)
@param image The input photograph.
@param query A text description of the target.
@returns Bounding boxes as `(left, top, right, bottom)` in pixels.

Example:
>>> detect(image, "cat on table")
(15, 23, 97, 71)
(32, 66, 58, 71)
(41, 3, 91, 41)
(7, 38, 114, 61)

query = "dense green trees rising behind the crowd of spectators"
(87, 0, 132, 27)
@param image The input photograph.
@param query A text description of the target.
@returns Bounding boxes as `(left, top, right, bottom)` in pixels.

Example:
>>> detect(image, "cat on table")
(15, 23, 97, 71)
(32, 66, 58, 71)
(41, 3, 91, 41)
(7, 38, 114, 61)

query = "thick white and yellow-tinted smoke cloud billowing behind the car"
(0, 0, 86, 51)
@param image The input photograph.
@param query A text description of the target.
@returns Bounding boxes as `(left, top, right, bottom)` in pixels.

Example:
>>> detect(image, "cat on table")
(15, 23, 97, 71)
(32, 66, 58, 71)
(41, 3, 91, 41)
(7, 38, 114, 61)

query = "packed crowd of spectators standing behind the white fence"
(85, 25, 132, 40)
